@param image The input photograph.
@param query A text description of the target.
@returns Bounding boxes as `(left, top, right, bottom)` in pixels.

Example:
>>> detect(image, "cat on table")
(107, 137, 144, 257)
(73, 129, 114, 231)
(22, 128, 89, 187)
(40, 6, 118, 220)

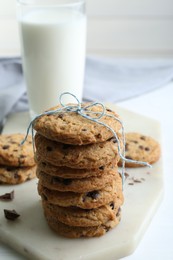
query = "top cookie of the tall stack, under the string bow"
(33, 103, 121, 145)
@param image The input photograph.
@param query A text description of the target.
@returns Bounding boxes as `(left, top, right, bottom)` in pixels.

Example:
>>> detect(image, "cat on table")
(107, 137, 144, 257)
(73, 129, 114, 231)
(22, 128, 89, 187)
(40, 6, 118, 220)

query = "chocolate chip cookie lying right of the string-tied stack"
(118, 133, 160, 167)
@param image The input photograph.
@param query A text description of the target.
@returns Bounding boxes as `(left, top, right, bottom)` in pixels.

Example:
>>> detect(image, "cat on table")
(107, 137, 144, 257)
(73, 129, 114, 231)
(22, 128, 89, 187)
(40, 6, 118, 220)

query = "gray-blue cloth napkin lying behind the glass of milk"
(0, 57, 173, 122)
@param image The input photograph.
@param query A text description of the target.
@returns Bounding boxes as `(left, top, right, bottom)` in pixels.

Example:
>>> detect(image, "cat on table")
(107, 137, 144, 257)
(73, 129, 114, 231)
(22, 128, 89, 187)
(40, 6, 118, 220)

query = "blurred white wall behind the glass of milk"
(0, 0, 173, 58)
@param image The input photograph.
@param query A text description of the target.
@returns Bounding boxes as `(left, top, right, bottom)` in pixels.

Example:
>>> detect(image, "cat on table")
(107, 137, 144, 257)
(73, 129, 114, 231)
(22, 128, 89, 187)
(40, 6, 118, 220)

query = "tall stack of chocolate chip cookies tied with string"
(33, 104, 123, 238)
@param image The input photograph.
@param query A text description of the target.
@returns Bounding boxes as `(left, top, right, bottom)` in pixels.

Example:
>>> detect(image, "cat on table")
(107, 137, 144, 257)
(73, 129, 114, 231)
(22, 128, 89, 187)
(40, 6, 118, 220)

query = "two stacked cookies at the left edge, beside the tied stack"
(0, 134, 36, 184)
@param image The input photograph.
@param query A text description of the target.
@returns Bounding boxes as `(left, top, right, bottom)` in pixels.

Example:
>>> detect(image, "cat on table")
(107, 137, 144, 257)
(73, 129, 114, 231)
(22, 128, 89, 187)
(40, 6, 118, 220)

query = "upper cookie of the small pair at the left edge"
(0, 134, 35, 166)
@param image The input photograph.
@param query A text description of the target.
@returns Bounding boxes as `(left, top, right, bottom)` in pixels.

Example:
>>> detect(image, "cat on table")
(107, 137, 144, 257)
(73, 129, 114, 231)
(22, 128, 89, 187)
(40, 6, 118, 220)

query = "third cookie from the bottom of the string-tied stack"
(38, 177, 124, 209)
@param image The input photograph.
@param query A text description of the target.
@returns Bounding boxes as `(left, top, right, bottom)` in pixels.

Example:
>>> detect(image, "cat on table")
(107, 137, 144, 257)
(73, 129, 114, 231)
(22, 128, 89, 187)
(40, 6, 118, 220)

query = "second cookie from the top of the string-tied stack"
(35, 133, 121, 169)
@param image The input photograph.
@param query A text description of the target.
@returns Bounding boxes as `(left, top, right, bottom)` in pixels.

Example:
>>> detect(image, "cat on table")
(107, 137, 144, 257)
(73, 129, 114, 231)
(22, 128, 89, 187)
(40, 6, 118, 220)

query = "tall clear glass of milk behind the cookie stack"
(17, 0, 86, 118)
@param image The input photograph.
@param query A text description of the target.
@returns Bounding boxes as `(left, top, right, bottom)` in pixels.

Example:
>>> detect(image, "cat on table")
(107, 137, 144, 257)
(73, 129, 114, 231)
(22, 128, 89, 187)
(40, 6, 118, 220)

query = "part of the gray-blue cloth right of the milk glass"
(84, 57, 173, 103)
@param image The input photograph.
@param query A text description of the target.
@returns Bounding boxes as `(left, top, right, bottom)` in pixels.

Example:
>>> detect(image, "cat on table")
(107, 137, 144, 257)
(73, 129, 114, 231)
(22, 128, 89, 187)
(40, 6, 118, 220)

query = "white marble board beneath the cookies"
(0, 105, 163, 260)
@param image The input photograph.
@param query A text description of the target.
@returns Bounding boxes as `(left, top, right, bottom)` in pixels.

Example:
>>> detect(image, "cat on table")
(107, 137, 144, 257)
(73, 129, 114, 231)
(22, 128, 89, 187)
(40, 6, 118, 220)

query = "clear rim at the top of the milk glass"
(17, 0, 85, 7)
